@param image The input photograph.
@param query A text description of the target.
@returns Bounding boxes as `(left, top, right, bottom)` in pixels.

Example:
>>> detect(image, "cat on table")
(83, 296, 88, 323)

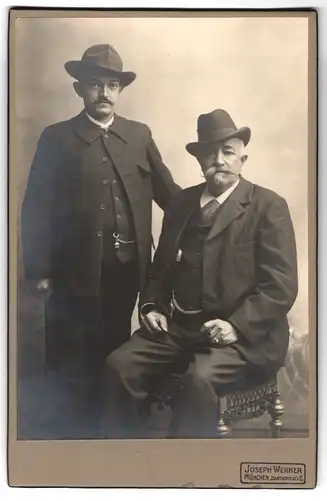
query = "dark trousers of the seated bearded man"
(105, 322, 254, 438)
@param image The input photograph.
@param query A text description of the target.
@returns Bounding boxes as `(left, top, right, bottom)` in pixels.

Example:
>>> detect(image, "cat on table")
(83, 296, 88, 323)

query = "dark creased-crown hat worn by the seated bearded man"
(186, 109, 251, 156)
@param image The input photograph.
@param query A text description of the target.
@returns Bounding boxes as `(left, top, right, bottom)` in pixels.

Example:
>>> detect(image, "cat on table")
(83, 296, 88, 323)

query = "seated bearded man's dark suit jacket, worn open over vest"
(140, 178, 297, 371)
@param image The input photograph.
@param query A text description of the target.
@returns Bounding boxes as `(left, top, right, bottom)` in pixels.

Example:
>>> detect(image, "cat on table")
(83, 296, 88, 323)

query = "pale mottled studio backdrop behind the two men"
(14, 18, 314, 437)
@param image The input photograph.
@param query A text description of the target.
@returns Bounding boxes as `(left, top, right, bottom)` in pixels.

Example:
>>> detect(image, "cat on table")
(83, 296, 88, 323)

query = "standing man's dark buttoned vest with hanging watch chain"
(97, 131, 137, 262)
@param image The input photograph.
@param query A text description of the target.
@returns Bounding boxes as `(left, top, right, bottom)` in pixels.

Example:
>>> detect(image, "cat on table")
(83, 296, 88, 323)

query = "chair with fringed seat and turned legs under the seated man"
(155, 367, 284, 438)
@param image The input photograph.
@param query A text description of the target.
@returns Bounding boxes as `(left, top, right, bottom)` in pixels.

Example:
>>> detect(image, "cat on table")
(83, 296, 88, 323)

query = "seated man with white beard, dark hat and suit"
(106, 110, 297, 437)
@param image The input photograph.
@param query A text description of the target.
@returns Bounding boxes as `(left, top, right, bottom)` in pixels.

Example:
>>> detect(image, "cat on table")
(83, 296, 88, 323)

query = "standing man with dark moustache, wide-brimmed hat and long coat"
(22, 45, 180, 420)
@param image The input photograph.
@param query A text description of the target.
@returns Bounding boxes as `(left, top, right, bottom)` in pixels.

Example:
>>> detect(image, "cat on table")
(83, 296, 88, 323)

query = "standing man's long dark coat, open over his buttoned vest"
(22, 112, 180, 295)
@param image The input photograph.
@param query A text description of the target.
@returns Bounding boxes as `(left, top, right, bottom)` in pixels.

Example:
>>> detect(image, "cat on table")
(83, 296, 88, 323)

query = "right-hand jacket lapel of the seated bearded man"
(207, 177, 253, 241)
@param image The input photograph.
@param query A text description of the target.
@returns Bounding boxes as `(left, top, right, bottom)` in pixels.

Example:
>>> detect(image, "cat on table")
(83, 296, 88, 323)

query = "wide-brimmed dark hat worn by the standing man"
(65, 44, 136, 87)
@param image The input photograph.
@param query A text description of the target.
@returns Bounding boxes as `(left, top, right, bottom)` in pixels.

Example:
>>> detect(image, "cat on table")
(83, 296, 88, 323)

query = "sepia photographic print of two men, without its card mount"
(10, 9, 316, 484)
